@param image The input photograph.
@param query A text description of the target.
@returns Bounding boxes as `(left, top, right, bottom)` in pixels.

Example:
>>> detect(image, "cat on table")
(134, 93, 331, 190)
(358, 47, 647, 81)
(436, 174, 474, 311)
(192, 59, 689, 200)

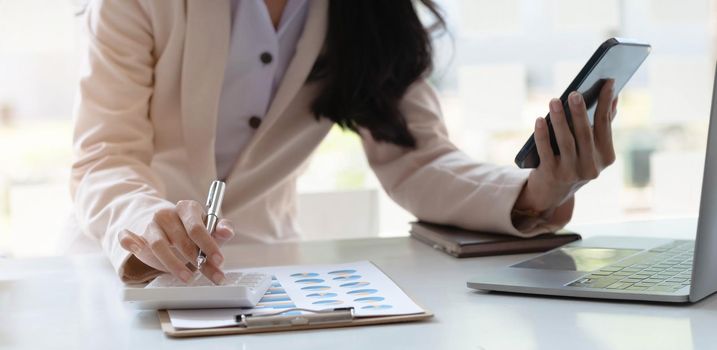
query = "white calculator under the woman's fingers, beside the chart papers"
(124, 272, 272, 310)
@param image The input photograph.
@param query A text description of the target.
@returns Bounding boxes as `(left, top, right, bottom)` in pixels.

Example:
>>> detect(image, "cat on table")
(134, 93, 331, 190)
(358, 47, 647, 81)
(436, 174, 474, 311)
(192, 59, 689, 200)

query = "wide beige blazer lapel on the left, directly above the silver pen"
(181, 0, 231, 191)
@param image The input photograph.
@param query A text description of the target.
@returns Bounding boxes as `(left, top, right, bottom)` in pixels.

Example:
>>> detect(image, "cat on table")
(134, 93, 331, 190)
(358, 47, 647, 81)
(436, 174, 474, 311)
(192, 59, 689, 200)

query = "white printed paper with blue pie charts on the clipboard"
(168, 261, 424, 329)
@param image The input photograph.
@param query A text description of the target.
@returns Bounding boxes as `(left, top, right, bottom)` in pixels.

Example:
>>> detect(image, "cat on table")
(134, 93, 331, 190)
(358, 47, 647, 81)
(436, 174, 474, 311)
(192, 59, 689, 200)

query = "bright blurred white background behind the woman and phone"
(0, 0, 717, 257)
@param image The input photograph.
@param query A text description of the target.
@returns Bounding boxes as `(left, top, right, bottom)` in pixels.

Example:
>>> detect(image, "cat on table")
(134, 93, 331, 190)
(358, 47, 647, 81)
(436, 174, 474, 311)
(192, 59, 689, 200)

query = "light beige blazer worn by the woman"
(71, 0, 572, 281)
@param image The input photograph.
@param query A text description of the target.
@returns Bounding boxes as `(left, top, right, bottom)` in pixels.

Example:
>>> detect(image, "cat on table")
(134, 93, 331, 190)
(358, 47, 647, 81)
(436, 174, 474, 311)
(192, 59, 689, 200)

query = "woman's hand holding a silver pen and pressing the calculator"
(119, 200, 234, 284)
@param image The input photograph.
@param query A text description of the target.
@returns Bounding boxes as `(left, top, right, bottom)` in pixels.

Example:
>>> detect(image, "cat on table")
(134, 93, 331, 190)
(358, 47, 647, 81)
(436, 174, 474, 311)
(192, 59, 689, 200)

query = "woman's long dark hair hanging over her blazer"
(309, 0, 445, 148)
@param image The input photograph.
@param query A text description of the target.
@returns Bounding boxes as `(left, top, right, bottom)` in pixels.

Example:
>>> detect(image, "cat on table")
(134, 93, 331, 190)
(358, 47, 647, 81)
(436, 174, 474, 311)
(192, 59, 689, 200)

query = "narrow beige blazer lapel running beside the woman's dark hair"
(230, 0, 329, 168)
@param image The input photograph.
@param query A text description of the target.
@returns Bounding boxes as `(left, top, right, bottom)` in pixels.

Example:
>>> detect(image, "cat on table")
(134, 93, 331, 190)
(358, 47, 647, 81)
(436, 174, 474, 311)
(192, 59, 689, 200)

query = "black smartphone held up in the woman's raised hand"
(515, 38, 652, 168)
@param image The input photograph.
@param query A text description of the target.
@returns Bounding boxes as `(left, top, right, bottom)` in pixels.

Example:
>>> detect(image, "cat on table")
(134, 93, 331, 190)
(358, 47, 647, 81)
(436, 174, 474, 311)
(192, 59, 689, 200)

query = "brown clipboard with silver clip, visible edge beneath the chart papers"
(158, 307, 433, 338)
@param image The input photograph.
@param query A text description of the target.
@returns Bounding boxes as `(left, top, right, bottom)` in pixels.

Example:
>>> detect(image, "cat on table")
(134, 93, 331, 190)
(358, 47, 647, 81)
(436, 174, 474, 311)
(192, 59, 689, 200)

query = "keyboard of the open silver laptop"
(567, 240, 694, 292)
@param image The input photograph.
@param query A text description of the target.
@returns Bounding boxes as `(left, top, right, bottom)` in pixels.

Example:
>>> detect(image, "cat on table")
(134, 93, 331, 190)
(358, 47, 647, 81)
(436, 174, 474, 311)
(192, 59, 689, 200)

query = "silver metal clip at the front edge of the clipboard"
(236, 307, 354, 329)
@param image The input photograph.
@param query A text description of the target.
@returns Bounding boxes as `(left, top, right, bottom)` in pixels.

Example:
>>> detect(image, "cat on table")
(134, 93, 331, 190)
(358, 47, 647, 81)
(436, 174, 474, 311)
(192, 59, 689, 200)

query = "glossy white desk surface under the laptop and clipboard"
(0, 220, 717, 350)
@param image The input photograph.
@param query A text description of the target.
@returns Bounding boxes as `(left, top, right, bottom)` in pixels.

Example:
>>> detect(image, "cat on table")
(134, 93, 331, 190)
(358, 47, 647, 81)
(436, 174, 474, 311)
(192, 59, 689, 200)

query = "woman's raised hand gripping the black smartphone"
(514, 80, 617, 223)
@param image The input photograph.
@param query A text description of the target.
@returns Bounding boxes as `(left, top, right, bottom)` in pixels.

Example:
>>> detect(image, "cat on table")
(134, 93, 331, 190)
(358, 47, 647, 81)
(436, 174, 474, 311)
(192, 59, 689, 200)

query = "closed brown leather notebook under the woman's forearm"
(411, 221, 581, 258)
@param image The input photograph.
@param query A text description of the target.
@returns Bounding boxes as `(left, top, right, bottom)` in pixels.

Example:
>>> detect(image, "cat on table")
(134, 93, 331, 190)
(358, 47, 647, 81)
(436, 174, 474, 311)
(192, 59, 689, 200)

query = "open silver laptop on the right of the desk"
(468, 66, 717, 303)
